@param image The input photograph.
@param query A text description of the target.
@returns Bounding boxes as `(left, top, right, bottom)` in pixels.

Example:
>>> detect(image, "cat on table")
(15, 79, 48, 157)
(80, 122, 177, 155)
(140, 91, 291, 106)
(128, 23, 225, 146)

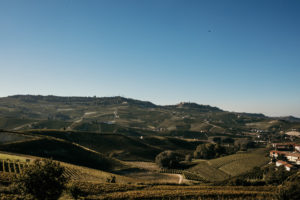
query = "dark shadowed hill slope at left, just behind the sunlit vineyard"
(0, 131, 126, 171)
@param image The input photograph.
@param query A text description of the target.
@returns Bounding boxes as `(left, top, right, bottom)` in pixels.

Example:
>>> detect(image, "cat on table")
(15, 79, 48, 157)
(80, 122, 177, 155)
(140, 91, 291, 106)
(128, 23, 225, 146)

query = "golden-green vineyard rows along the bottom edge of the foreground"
(87, 185, 276, 200)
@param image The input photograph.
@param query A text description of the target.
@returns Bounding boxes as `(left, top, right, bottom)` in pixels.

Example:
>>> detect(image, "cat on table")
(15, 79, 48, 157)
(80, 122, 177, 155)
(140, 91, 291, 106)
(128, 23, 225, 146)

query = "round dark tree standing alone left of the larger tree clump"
(155, 151, 183, 168)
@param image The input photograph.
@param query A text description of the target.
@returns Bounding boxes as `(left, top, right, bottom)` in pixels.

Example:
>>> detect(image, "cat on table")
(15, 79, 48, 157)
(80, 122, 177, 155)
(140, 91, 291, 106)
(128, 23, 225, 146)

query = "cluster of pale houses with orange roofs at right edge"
(270, 143, 300, 171)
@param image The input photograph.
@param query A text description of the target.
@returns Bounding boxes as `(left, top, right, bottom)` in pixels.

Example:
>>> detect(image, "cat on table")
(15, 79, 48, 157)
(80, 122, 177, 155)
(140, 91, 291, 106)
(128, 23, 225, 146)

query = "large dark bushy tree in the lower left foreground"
(16, 159, 67, 200)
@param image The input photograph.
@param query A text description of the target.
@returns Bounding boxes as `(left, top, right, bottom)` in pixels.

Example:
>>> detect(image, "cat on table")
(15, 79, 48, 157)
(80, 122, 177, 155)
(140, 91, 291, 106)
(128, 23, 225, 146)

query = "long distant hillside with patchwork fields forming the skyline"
(0, 95, 300, 135)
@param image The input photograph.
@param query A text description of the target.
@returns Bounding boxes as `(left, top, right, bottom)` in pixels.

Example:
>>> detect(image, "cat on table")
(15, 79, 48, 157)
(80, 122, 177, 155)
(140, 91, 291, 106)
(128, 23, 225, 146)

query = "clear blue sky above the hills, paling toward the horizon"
(0, 0, 300, 117)
